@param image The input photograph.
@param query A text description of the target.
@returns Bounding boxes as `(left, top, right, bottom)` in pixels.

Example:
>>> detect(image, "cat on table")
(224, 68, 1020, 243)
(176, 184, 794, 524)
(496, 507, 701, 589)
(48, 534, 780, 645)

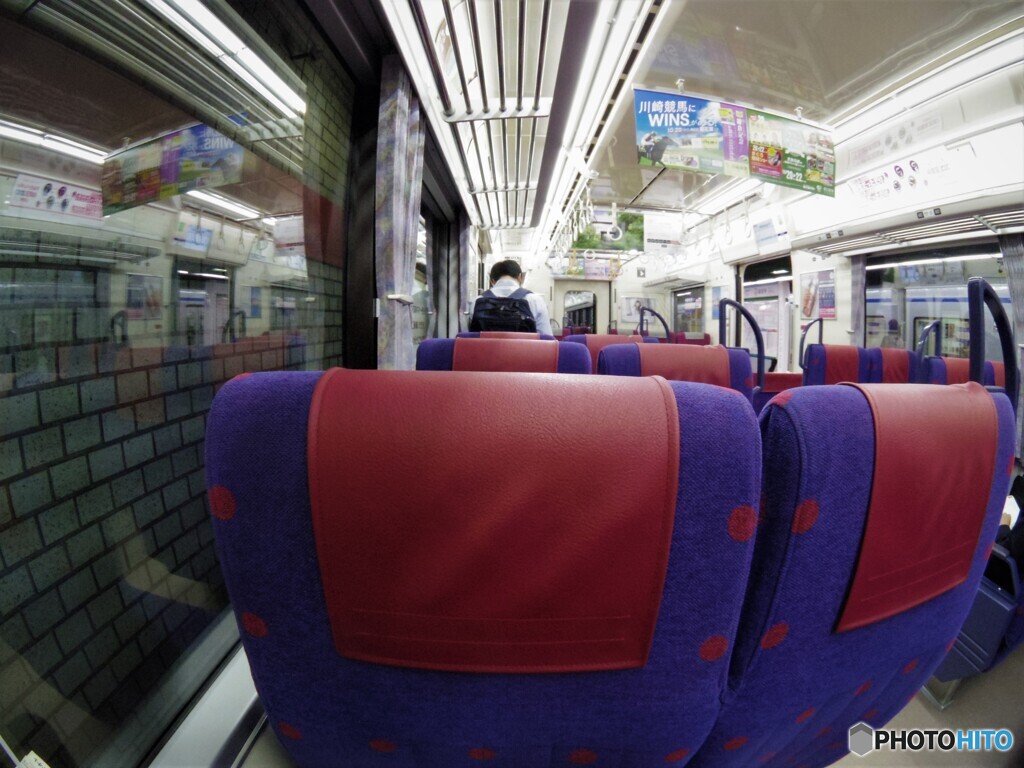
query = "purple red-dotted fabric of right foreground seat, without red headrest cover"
(690, 384, 1014, 768)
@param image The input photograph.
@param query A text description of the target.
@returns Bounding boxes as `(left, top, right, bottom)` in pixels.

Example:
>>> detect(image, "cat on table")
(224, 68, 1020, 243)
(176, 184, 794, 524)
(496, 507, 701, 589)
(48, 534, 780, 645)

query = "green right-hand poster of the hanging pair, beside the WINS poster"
(748, 110, 836, 198)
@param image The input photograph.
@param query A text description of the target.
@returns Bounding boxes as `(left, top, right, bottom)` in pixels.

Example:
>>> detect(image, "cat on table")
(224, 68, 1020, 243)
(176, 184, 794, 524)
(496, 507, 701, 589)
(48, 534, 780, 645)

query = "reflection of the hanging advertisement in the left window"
(100, 125, 243, 216)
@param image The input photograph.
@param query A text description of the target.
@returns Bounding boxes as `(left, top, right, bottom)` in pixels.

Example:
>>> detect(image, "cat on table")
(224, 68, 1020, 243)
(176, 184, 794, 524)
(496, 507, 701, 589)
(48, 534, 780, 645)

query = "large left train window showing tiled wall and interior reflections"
(0, 3, 353, 768)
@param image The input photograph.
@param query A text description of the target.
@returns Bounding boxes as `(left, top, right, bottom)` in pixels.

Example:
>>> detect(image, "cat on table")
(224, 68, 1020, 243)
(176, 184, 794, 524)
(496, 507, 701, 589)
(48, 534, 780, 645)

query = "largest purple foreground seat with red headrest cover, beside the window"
(206, 369, 760, 768)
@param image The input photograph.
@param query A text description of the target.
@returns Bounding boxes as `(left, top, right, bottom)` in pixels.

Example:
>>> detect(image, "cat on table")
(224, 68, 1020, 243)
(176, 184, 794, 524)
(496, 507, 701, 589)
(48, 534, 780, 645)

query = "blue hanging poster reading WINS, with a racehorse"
(633, 89, 750, 176)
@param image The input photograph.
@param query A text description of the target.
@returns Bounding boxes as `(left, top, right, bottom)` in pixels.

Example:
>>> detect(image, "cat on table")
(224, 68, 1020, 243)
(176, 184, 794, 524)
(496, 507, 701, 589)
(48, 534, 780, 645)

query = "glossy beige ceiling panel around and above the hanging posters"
(590, 0, 1021, 217)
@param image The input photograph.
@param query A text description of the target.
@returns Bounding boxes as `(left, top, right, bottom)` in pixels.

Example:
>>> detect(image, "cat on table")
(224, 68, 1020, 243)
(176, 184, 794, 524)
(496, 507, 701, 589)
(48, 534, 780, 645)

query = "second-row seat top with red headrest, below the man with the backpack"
(416, 337, 591, 374)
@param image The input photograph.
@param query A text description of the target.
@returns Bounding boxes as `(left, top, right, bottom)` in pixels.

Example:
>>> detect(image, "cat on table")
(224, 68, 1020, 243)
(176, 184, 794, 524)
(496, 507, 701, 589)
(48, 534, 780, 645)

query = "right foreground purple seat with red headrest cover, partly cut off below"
(690, 383, 1015, 768)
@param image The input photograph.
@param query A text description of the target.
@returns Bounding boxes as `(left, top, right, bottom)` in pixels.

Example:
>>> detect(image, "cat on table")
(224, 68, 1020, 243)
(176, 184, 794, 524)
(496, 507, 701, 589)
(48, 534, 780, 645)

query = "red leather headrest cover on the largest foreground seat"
(308, 370, 679, 673)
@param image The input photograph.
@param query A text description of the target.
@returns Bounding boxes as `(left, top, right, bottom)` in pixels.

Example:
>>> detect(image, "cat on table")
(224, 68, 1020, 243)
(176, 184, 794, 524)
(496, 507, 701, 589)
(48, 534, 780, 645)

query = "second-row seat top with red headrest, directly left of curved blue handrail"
(597, 344, 754, 400)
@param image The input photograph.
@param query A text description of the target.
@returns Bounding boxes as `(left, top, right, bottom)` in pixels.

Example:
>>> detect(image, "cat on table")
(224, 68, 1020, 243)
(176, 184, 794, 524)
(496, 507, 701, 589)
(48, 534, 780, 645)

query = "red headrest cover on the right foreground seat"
(837, 383, 998, 632)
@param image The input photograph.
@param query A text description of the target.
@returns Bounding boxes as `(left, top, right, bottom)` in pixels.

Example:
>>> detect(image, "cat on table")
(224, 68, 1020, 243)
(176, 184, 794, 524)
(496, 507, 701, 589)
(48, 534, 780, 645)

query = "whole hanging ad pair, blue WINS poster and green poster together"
(633, 88, 836, 197)
